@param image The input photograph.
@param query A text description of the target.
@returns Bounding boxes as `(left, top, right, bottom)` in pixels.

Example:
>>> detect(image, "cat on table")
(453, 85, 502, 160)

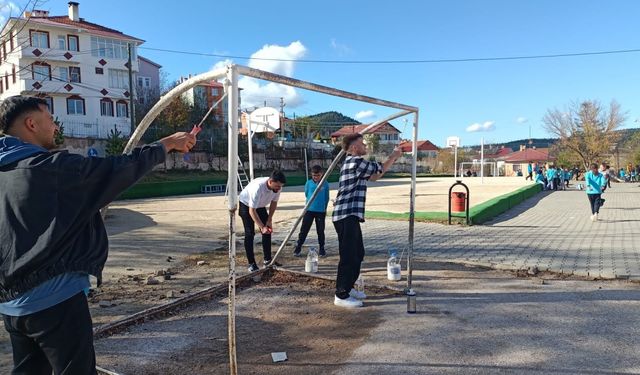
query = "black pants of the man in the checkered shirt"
(333, 216, 364, 299)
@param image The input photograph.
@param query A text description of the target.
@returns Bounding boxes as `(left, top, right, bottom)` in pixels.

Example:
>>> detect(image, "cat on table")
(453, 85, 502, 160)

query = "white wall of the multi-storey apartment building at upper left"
(0, 20, 138, 138)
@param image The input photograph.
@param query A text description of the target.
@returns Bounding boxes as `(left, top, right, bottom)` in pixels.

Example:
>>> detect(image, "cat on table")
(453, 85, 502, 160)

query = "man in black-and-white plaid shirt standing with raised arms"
(333, 134, 402, 307)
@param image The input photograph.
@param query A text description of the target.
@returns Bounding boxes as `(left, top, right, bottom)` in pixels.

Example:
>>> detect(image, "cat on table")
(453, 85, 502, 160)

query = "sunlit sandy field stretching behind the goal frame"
(0, 178, 526, 373)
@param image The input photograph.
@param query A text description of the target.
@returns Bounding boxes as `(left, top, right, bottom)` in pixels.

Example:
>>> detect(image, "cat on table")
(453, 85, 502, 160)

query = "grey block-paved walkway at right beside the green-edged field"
(281, 183, 640, 279)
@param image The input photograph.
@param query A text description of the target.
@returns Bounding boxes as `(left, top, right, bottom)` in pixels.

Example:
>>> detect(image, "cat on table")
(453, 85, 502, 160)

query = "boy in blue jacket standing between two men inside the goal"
(293, 165, 329, 257)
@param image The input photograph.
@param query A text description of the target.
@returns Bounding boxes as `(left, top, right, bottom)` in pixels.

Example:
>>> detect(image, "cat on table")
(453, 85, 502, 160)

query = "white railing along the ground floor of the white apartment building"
(59, 116, 131, 139)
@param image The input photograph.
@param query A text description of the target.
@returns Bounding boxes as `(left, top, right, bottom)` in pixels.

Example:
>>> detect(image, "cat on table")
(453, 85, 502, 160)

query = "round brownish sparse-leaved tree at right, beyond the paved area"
(543, 100, 626, 170)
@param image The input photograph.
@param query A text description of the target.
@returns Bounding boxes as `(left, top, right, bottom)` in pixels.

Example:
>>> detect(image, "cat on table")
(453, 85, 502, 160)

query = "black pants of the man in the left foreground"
(4, 292, 96, 375)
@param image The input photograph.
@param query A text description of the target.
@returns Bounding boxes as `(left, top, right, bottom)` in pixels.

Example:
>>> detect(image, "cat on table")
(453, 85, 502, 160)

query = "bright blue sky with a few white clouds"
(1, 0, 640, 146)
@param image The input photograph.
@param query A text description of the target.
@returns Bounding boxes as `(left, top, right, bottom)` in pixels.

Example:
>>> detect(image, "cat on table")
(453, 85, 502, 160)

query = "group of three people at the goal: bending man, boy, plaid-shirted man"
(239, 134, 402, 307)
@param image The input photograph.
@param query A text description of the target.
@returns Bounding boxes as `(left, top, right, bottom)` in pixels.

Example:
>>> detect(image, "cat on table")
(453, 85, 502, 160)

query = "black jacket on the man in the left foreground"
(0, 137, 165, 302)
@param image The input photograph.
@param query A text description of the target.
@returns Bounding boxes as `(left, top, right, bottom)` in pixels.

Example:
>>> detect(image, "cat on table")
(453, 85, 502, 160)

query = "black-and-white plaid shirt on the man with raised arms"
(333, 155, 382, 222)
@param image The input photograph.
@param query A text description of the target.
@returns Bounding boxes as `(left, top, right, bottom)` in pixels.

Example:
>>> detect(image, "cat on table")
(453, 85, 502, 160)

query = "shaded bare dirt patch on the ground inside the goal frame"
(96, 272, 397, 375)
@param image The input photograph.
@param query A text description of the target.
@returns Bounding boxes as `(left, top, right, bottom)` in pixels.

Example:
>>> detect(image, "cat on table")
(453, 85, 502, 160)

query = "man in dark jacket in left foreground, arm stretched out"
(0, 96, 196, 374)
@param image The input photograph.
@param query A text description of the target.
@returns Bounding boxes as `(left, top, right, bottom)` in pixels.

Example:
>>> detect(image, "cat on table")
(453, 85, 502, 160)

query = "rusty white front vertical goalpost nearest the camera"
(227, 65, 238, 375)
